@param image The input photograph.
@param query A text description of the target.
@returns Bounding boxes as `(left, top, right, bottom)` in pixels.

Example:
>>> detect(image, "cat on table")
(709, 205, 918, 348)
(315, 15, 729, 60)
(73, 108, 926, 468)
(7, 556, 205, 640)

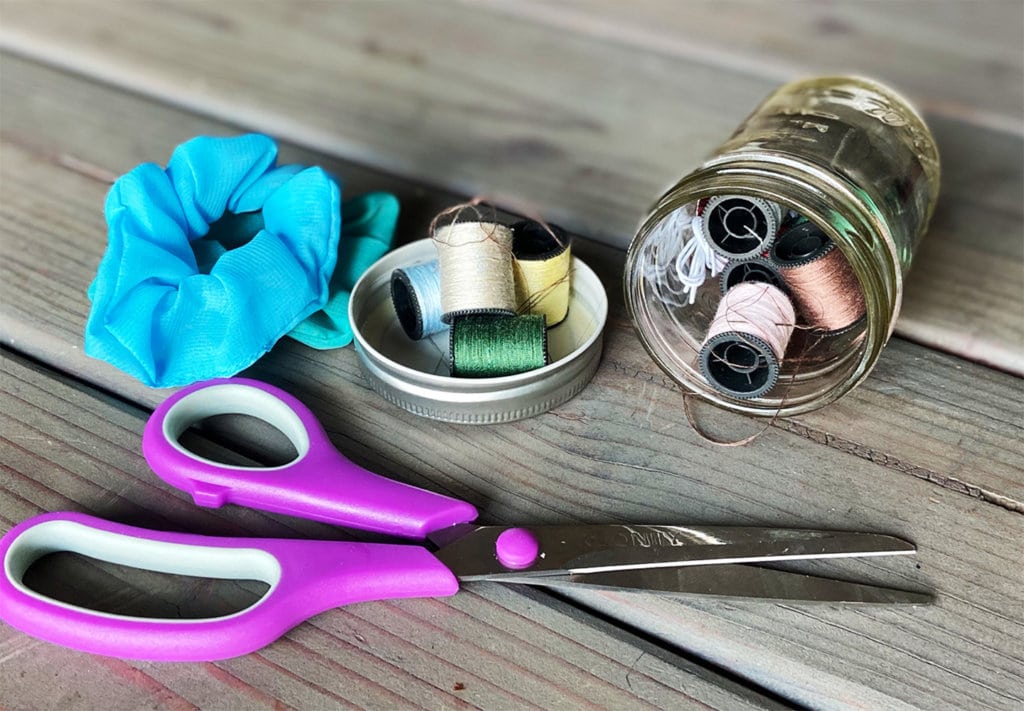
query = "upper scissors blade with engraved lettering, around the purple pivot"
(428, 524, 915, 580)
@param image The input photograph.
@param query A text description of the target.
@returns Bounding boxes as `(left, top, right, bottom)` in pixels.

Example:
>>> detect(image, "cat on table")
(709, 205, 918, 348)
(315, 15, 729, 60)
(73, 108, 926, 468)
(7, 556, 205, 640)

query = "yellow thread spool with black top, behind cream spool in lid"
(512, 219, 572, 328)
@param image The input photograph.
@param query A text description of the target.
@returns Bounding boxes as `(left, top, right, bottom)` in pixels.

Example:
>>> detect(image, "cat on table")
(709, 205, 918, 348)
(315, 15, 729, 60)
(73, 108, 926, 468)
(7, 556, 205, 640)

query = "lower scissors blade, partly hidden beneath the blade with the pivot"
(524, 564, 934, 604)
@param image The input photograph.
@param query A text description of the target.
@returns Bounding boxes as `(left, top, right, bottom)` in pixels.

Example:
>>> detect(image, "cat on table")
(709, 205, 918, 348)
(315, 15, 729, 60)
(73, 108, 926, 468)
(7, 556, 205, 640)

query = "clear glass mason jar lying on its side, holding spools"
(625, 77, 939, 416)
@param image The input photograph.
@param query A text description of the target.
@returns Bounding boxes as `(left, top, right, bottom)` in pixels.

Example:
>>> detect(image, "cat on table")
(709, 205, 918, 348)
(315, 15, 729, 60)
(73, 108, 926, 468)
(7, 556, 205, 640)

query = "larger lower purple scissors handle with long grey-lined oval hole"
(0, 512, 459, 662)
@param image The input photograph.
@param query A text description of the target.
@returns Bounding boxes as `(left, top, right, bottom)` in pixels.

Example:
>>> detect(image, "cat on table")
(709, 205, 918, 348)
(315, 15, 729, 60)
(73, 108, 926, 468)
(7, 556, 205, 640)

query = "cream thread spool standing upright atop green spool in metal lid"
(433, 222, 515, 324)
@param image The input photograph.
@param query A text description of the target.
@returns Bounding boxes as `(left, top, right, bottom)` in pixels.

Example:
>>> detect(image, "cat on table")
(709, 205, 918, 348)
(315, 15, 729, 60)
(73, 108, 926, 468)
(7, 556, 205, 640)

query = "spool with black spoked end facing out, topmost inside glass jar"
(701, 195, 782, 259)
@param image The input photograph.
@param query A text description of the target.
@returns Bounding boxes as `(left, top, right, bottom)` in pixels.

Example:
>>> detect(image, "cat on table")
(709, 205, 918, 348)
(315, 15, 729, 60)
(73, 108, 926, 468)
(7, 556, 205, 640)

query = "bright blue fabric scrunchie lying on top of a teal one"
(85, 134, 341, 387)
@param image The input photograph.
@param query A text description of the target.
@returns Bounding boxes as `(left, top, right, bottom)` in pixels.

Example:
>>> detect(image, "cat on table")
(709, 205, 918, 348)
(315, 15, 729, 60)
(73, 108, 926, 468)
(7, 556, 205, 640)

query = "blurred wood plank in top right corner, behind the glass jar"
(475, 0, 1024, 137)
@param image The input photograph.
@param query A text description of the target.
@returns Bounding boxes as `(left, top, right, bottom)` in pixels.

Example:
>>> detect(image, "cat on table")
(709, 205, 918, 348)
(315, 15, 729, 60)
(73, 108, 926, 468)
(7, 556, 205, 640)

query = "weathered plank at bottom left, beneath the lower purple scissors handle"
(0, 353, 779, 709)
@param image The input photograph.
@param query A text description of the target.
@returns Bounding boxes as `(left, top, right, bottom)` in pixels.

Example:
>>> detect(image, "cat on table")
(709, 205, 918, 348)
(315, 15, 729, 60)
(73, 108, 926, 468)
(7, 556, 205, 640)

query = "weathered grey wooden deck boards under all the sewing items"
(0, 0, 1024, 711)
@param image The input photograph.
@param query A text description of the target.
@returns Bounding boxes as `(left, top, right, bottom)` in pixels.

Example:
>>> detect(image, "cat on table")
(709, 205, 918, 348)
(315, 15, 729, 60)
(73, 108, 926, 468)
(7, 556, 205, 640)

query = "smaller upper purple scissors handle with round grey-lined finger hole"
(142, 378, 477, 539)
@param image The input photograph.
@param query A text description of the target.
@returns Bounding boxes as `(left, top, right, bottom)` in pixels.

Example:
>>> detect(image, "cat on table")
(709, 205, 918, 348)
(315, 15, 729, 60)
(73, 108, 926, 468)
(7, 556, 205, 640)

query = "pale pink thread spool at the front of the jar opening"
(698, 282, 796, 400)
